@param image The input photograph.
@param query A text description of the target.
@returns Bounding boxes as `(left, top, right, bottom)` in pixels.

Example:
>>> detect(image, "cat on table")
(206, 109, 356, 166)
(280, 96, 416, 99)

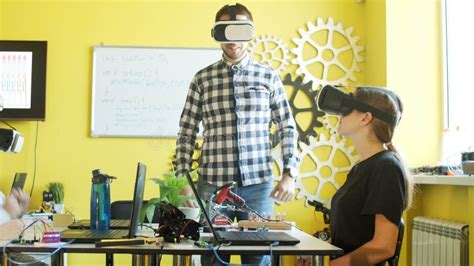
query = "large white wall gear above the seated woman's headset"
(291, 17, 364, 89)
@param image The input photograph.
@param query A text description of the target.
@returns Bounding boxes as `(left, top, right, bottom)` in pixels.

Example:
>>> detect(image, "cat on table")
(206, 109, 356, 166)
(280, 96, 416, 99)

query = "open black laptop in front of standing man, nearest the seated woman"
(186, 172, 300, 246)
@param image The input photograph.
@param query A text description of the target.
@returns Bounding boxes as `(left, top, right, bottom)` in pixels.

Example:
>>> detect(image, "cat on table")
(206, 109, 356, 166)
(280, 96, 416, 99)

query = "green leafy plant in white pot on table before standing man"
(140, 170, 199, 222)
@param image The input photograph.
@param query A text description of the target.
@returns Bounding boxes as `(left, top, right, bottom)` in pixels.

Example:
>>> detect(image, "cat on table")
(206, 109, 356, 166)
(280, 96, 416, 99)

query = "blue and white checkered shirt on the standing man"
(176, 55, 299, 186)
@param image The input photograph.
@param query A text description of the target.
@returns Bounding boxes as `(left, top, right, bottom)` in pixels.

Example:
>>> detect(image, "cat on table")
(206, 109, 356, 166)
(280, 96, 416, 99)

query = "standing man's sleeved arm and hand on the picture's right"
(270, 75, 299, 201)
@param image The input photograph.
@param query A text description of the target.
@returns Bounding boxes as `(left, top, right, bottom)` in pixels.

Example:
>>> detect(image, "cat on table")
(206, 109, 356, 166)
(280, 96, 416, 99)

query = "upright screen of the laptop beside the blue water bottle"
(128, 163, 146, 238)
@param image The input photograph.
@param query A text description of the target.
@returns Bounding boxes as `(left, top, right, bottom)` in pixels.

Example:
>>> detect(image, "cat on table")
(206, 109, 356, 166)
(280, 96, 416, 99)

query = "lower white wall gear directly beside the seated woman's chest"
(272, 134, 359, 206)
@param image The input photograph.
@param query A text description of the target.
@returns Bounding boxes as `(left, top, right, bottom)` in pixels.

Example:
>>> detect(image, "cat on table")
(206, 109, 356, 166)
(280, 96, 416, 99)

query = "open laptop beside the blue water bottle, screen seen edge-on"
(61, 163, 146, 243)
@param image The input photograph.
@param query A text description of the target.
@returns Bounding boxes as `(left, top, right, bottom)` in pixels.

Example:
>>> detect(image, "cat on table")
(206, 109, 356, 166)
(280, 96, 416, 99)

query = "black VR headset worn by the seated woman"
(316, 85, 401, 126)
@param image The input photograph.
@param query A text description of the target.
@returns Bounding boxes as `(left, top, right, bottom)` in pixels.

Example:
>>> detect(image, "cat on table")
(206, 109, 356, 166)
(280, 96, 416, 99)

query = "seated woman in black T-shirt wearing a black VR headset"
(317, 86, 413, 266)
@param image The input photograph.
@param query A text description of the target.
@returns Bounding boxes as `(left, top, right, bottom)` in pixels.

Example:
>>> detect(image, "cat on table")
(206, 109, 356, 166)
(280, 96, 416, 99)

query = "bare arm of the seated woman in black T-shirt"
(329, 214, 398, 266)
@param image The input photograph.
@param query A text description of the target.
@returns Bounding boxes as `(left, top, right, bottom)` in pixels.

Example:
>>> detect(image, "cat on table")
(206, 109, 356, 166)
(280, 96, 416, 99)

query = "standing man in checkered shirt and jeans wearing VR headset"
(176, 4, 299, 265)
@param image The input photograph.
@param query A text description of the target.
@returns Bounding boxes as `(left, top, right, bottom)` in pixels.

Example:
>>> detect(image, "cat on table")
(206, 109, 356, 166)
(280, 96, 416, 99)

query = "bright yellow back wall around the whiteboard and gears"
(0, 0, 385, 263)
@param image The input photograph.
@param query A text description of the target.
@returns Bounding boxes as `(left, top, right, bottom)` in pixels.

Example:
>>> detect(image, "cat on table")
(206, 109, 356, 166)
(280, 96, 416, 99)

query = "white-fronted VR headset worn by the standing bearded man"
(211, 6, 255, 43)
